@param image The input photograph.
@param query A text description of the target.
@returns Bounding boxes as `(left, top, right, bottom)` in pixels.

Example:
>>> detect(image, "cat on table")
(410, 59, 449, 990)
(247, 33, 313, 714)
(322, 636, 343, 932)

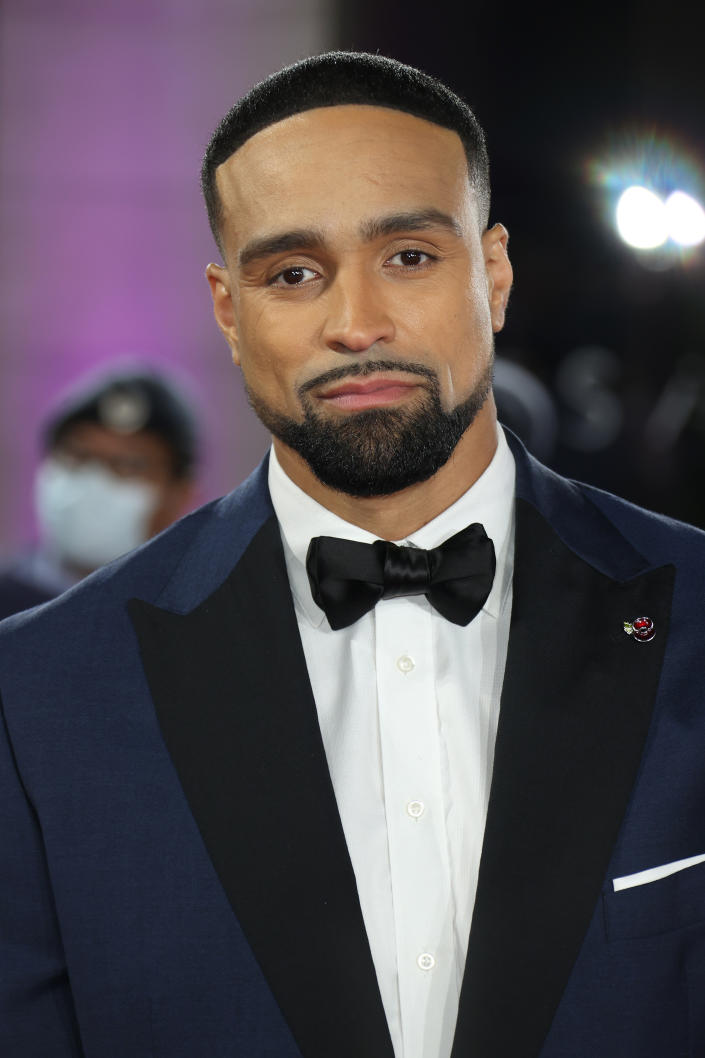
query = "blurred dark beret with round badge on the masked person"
(41, 367, 197, 478)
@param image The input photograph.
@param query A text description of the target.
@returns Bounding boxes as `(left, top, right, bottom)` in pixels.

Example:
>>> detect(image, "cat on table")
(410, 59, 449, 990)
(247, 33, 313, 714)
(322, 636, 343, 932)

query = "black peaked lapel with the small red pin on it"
(453, 500, 673, 1058)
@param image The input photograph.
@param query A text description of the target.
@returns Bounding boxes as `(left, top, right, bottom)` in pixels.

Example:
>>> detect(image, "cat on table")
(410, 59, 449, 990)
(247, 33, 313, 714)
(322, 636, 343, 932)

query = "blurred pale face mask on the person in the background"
(35, 458, 159, 569)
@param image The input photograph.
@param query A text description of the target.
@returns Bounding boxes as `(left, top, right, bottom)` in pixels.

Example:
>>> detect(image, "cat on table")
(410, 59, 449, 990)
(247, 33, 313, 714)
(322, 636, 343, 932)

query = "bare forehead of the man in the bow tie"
(216, 106, 472, 249)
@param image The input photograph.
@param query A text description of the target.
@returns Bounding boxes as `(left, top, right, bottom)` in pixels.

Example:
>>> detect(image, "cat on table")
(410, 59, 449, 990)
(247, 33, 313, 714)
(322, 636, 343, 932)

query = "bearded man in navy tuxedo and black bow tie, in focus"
(0, 53, 705, 1058)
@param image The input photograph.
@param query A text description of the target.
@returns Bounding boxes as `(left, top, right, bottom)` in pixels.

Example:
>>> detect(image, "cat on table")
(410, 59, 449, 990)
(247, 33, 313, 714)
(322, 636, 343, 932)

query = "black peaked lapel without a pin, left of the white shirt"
(130, 518, 393, 1058)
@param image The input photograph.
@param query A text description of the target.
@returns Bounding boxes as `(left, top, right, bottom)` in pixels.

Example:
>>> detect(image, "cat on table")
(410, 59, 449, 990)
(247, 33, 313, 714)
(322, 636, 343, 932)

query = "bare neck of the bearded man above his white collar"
(274, 399, 496, 540)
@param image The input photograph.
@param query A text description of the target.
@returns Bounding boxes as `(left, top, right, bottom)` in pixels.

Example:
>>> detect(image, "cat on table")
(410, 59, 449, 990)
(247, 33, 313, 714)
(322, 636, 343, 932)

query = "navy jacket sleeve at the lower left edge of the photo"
(0, 689, 84, 1058)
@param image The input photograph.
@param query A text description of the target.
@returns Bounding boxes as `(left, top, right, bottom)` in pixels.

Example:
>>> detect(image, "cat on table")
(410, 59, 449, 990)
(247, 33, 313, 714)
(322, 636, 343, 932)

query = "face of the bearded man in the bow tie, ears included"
(209, 106, 511, 495)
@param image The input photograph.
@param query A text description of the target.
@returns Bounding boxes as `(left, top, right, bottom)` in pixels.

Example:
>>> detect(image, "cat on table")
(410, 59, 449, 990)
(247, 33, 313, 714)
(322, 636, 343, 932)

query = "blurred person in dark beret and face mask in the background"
(0, 366, 196, 618)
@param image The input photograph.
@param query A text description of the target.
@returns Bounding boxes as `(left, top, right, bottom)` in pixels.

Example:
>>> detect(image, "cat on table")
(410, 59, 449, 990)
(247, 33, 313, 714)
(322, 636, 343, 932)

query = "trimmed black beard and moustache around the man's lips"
(246, 361, 492, 496)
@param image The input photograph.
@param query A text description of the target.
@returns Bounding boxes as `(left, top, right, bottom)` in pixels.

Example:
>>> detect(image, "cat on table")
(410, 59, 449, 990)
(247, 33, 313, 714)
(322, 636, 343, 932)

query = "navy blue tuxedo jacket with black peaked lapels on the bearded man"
(0, 431, 705, 1058)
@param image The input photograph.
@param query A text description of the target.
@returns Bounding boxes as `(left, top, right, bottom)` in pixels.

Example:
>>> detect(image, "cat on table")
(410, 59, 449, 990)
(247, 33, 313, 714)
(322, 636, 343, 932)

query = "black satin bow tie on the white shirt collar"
(306, 522, 495, 630)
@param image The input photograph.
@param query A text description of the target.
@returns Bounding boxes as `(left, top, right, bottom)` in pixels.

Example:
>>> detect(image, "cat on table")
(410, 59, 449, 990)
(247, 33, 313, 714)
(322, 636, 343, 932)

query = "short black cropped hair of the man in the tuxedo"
(201, 52, 490, 250)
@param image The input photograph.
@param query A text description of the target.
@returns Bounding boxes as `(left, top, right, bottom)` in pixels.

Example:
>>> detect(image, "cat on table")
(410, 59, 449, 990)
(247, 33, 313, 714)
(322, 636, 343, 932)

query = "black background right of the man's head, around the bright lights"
(338, 0, 705, 526)
